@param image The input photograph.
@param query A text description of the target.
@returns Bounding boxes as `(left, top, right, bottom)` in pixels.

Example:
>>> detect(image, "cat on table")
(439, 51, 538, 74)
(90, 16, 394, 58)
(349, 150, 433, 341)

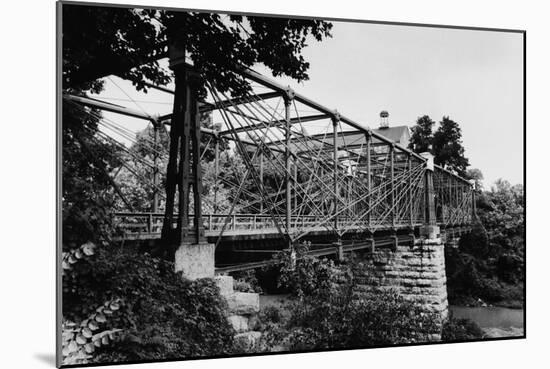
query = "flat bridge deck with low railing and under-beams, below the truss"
(114, 213, 471, 274)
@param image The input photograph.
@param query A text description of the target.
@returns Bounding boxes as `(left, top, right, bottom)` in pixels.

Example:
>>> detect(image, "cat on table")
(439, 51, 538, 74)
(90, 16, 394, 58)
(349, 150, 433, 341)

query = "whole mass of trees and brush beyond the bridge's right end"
(409, 115, 525, 307)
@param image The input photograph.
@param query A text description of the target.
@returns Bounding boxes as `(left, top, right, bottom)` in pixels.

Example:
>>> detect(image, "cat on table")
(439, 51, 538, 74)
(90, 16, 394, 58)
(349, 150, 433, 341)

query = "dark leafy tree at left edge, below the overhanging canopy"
(61, 104, 120, 250)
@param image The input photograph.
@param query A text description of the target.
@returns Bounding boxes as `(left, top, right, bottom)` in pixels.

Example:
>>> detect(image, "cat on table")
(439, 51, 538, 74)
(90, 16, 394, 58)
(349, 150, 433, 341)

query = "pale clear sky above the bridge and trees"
(102, 22, 523, 188)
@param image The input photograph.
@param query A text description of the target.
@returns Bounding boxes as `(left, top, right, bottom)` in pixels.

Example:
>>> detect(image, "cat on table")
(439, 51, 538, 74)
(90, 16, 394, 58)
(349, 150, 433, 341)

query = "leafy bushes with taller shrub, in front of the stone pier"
(252, 244, 438, 351)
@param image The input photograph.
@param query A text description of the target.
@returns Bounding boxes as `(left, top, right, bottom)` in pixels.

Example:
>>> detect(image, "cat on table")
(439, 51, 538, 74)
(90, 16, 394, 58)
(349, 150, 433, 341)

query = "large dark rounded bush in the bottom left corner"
(63, 249, 234, 362)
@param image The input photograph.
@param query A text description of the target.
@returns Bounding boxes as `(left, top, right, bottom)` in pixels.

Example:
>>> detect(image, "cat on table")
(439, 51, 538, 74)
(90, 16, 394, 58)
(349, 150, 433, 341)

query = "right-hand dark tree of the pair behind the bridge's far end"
(433, 116, 470, 177)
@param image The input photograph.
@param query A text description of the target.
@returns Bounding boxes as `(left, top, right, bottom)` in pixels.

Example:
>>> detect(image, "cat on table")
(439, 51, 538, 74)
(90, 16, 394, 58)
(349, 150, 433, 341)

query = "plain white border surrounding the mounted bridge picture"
(0, 0, 550, 369)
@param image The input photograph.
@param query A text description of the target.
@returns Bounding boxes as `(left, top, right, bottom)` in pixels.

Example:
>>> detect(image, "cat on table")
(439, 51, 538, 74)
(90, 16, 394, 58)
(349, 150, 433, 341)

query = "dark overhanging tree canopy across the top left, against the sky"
(63, 4, 332, 93)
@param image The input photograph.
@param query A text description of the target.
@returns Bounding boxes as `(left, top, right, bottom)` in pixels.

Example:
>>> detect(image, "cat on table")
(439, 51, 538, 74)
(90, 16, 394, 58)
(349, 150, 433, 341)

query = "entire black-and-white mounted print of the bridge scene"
(57, 1, 525, 367)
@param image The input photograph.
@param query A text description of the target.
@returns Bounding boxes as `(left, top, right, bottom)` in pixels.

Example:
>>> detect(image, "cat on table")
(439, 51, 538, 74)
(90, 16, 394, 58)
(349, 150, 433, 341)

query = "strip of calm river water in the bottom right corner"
(449, 306, 524, 337)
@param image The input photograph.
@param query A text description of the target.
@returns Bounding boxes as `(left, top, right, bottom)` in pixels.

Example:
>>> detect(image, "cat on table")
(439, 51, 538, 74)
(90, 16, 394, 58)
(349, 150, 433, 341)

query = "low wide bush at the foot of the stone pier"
(289, 287, 439, 350)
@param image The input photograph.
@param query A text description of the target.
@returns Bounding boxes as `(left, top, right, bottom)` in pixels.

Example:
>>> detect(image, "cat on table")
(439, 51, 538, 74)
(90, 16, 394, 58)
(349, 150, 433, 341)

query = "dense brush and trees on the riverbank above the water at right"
(445, 180, 525, 307)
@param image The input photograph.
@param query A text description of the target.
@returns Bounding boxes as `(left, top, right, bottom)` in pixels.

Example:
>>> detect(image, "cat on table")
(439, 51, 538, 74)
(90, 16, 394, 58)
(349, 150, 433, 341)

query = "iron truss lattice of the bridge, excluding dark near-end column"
(63, 63, 474, 244)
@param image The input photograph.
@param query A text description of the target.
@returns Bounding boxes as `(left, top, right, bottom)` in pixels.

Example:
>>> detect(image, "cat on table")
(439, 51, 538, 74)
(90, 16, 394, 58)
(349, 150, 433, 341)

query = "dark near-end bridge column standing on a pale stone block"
(162, 47, 215, 279)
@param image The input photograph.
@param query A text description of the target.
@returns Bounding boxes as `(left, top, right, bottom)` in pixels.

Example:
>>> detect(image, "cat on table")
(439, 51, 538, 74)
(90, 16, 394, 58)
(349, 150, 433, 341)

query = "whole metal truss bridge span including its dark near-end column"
(63, 59, 475, 268)
